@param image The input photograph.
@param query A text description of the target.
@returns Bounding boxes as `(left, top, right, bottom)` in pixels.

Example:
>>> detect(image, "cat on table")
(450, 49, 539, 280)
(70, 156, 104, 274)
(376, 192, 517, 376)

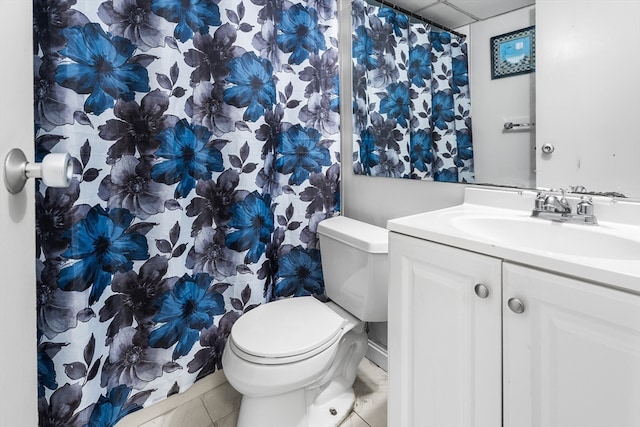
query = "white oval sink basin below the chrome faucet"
(451, 215, 640, 260)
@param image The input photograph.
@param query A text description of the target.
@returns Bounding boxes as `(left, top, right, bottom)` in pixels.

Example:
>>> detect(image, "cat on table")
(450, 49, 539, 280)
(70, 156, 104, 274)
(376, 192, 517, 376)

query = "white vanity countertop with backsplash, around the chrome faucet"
(387, 188, 640, 293)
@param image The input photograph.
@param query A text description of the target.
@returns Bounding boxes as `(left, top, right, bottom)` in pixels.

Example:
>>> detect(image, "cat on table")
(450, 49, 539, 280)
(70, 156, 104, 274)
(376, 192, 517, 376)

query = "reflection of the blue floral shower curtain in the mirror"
(352, 0, 474, 183)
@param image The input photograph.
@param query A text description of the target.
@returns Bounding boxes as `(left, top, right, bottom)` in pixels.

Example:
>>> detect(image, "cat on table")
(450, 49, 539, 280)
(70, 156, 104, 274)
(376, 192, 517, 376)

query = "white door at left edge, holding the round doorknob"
(0, 0, 37, 427)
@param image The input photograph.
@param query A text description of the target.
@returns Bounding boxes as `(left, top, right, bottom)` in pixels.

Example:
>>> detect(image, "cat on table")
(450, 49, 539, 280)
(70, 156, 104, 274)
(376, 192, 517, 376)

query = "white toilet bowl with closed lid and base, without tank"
(222, 297, 367, 427)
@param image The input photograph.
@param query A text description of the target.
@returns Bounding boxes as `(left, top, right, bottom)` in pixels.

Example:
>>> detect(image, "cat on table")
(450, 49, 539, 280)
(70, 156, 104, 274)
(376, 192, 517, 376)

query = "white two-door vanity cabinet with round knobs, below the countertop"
(389, 232, 640, 427)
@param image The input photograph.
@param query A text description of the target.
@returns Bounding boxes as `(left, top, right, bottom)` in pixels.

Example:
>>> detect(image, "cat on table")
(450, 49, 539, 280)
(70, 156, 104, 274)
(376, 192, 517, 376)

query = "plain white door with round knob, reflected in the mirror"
(536, 0, 640, 198)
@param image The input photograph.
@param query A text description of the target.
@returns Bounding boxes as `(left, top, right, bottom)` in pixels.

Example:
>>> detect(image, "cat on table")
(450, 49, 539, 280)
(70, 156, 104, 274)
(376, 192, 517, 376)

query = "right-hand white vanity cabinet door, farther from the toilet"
(503, 263, 640, 427)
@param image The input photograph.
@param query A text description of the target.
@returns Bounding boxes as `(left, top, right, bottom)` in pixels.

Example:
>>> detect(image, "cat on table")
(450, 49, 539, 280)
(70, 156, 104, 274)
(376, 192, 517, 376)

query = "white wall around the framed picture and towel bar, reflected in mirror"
(468, 6, 536, 187)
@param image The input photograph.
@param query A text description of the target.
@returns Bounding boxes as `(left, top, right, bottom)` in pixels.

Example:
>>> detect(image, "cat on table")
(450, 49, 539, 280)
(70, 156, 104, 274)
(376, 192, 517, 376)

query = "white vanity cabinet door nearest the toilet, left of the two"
(388, 233, 502, 427)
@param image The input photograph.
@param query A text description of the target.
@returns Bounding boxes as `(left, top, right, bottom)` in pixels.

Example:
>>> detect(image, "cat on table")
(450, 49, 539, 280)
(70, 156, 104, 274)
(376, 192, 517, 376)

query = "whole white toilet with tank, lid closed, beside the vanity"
(222, 216, 388, 427)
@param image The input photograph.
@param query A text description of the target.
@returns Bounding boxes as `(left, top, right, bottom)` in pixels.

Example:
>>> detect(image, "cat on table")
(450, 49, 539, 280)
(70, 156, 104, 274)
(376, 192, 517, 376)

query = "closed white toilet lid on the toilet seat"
(231, 297, 347, 358)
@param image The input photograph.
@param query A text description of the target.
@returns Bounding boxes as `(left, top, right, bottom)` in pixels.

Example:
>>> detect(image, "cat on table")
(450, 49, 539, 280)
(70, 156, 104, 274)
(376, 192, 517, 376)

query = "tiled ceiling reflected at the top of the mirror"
(390, 0, 535, 28)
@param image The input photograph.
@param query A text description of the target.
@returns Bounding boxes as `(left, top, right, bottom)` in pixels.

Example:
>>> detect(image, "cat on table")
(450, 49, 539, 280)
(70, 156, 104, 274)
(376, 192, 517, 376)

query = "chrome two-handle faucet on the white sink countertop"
(531, 190, 598, 225)
